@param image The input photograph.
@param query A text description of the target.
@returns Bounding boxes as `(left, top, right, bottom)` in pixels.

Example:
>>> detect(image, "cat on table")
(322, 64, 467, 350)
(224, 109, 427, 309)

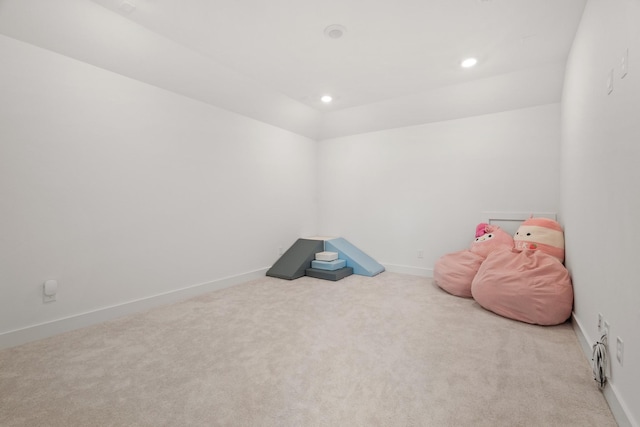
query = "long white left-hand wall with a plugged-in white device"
(0, 36, 317, 344)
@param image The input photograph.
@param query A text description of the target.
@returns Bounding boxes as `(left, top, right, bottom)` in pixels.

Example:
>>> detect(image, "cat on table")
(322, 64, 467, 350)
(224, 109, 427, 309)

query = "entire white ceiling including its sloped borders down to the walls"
(0, 0, 586, 138)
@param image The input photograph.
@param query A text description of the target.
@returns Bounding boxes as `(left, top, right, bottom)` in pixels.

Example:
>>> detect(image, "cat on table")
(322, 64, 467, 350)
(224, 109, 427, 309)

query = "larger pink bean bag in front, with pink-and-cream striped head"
(471, 218, 573, 325)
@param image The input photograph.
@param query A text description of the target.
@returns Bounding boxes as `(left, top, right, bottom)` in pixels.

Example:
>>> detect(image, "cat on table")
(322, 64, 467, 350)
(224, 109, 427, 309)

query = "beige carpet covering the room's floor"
(0, 272, 615, 427)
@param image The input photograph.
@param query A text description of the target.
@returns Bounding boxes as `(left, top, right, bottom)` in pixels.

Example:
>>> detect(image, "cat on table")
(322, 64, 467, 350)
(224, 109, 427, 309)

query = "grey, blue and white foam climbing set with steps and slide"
(267, 237, 384, 281)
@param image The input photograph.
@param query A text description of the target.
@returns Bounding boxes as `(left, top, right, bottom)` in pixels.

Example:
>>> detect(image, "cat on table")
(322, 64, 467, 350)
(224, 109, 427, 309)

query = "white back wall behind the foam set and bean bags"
(318, 104, 560, 275)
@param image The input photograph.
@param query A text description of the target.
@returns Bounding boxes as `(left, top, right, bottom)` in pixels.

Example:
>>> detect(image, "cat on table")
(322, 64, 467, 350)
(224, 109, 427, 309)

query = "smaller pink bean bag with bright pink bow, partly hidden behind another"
(433, 223, 513, 298)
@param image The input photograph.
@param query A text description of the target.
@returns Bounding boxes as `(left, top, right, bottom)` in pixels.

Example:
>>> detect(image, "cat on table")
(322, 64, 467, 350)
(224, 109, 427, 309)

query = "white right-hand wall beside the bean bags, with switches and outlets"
(561, 0, 640, 425)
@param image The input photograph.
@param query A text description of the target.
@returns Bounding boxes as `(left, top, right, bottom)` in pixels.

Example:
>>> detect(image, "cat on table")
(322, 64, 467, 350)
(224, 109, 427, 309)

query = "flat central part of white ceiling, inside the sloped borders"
(94, 0, 585, 110)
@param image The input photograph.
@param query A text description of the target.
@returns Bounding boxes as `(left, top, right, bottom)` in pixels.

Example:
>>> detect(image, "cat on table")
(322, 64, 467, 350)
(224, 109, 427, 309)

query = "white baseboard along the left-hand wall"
(0, 267, 268, 350)
